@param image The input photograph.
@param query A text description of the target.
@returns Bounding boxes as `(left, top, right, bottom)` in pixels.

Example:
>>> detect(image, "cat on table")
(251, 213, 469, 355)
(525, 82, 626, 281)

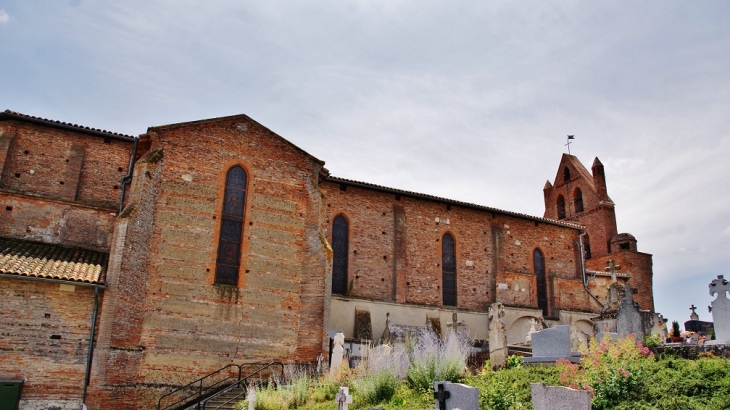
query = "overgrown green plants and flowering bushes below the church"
(241, 338, 730, 410)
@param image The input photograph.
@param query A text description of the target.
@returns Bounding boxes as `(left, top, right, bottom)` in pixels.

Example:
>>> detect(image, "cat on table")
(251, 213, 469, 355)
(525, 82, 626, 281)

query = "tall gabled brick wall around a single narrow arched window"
(84, 116, 329, 408)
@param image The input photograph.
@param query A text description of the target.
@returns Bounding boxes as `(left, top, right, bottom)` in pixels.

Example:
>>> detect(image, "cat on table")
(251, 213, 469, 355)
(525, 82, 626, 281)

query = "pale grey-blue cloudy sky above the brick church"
(0, 0, 730, 322)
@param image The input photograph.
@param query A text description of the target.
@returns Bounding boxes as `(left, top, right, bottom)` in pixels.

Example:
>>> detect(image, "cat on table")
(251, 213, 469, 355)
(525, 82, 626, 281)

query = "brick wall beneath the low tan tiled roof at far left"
(0, 278, 94, 408)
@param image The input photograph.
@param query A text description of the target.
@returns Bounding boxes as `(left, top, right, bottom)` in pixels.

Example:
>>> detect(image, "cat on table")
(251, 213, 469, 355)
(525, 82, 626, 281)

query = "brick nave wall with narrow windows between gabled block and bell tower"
(320, 181, 593, 311)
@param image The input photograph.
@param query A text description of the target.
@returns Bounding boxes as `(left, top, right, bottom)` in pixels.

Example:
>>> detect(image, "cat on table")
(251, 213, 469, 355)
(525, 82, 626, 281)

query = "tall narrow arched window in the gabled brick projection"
(215, 166, 246, 286)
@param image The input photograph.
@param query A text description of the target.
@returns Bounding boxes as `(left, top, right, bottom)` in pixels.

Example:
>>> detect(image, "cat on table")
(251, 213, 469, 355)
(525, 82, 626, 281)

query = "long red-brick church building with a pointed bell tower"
(0, 111, 654, 409)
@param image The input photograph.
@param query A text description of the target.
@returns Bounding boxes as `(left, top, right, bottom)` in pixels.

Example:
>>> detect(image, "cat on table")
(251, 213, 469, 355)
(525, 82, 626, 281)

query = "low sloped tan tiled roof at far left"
(0, 238, 109, 284)
